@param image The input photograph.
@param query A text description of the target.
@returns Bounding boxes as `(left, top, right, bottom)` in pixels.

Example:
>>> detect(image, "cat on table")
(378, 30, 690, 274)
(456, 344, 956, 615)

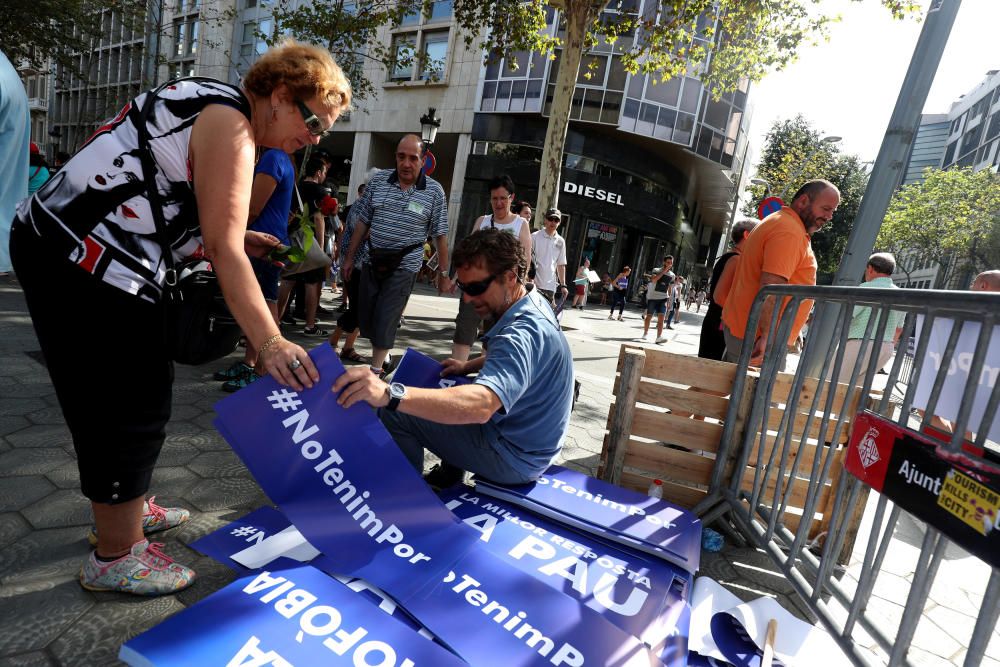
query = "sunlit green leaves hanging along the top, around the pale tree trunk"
(274, 0, 919, 105)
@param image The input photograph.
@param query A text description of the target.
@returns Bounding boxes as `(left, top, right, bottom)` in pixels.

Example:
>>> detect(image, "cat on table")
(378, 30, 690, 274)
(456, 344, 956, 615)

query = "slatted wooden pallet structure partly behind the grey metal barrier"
(598, 344, 864, 561)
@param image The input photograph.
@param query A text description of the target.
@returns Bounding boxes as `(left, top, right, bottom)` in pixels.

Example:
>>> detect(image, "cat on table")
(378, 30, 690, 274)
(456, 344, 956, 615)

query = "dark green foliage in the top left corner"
(0, 0, 146, 74)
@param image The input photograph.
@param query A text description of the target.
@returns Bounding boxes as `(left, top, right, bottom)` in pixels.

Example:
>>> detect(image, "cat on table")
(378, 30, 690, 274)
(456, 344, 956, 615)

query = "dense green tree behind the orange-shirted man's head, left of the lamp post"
(744, 115, 868, 273)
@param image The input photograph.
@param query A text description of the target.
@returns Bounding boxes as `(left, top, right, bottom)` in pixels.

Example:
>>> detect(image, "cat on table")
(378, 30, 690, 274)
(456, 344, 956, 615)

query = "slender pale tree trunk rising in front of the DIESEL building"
(535, 0, 596, 224)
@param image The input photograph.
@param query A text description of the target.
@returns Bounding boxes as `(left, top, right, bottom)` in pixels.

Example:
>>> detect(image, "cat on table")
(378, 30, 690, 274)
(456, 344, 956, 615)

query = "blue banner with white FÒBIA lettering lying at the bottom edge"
(118, 565, 464, 667)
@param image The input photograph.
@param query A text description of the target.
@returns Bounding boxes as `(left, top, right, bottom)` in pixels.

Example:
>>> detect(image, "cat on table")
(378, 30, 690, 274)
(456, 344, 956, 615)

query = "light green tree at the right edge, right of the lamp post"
(877, 167, 1000, 286)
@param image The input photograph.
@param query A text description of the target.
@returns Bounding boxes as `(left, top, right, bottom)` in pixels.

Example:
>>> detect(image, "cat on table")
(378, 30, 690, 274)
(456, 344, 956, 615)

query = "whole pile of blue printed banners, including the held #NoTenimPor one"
(121, 345, 698, 667)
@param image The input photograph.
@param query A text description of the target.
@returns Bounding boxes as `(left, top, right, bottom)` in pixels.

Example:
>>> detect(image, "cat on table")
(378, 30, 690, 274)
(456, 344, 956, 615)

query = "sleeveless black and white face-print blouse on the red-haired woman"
(14, 78, 250, 302)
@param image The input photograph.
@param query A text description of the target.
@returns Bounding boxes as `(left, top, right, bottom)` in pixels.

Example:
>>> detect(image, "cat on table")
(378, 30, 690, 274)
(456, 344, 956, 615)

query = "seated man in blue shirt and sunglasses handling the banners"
(333, 229, 573, 484)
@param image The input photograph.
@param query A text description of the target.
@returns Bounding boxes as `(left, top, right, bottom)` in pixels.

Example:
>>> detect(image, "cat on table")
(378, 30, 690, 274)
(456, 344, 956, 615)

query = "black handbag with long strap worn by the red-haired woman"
(137, 81, 241, 366)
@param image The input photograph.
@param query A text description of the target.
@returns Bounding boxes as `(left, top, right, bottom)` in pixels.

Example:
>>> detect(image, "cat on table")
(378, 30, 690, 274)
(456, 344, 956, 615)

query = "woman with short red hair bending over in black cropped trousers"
(11, 41, 351, 595)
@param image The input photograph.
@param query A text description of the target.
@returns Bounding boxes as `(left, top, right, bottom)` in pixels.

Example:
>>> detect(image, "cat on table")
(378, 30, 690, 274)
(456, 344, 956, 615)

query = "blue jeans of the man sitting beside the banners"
(378, 408, 542, 484)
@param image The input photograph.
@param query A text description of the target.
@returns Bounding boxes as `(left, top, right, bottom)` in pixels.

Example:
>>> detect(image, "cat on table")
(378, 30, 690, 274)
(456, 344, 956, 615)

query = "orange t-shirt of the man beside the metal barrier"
(722, 206, 817, 345)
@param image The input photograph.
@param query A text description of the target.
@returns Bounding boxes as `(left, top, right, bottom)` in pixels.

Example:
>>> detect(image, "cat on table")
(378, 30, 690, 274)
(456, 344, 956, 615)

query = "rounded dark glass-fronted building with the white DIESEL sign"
(468, 0, 749, 288)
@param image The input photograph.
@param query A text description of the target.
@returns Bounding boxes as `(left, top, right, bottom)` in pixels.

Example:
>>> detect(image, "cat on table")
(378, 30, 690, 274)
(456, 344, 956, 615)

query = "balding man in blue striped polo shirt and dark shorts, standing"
(341, 134, 453, 374)
